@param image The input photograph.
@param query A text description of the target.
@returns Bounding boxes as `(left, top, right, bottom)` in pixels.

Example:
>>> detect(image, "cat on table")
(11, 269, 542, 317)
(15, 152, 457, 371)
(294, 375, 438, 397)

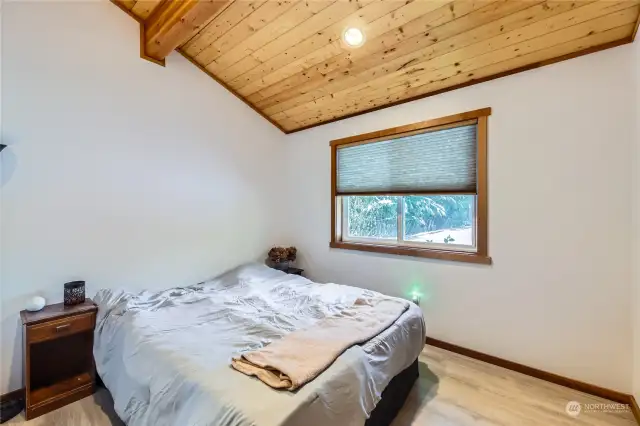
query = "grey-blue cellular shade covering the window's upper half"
(336, 124, 477, 195)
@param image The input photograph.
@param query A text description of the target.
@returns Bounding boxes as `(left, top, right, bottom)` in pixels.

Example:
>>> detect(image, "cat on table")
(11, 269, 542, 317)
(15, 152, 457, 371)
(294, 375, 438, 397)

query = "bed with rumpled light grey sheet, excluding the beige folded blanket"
(94, 264, 425, 426)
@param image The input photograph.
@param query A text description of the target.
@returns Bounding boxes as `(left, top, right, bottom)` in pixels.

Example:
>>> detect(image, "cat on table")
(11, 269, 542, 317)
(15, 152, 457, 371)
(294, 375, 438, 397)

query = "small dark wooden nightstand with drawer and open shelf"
(20, 299, 98, 420)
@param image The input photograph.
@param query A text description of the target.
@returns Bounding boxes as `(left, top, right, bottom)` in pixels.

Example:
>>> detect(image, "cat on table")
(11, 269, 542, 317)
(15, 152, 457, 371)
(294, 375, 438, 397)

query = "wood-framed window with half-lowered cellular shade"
(330, 108, 491, 263)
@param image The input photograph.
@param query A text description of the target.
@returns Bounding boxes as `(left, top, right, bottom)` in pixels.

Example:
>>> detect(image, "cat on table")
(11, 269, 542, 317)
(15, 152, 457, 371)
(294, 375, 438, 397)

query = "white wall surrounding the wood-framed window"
(286, 46, 636, 392)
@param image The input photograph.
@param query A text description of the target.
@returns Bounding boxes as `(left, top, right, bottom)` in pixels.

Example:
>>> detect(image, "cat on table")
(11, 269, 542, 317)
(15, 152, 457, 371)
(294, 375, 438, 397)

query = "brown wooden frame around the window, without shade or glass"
(329, 108, 491, 265)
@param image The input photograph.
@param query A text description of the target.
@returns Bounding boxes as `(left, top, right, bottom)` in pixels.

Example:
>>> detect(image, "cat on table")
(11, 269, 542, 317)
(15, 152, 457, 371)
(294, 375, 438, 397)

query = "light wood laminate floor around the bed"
(7, 346, 636, 426)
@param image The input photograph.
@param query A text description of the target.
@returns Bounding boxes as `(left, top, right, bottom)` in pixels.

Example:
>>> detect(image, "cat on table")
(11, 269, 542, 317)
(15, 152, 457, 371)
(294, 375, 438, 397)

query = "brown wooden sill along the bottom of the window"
(329, 241, 491, 265)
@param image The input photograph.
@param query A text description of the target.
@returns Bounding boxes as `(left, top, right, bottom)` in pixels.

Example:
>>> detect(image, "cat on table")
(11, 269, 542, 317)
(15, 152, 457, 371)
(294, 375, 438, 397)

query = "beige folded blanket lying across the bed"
(231, 297, 409, 391)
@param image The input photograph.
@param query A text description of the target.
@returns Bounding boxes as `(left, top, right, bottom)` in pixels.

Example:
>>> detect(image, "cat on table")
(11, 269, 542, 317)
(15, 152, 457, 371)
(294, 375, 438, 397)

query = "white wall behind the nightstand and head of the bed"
(0, 1, 283, 393)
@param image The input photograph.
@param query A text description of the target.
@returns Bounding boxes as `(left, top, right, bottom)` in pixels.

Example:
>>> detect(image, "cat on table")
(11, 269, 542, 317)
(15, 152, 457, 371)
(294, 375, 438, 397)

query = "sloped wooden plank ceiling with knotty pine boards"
(114, 0, 640, 132)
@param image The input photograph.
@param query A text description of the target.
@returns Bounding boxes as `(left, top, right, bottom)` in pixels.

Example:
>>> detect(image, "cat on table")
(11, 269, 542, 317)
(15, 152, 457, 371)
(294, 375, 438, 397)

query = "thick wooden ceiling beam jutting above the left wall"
(140, 0, 231, 65)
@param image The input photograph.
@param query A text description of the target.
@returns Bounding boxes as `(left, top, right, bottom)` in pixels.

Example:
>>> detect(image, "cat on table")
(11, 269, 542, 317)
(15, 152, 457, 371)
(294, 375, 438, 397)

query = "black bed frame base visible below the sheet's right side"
(364, 359, 418, 426)
